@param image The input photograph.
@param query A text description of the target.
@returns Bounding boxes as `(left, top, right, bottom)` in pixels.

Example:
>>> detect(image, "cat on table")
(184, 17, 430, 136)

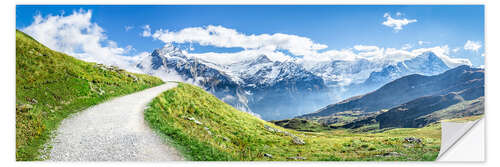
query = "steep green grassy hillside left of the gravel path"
(16, 31, 163, 161)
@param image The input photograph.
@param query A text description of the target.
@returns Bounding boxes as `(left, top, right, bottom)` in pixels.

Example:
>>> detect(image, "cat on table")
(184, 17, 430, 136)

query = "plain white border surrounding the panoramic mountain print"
(0, 0, 500, 167)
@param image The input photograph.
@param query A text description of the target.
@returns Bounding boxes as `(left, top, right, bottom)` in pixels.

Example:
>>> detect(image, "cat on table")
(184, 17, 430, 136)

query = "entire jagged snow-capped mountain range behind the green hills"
(137, 45, 458, 120)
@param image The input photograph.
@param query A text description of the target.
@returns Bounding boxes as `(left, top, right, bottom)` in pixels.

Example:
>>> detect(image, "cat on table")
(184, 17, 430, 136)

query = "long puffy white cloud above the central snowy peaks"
(142, 25, 327, 55)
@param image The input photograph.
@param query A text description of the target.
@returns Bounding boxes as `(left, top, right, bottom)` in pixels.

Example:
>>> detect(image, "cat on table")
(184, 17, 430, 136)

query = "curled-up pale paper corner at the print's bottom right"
(436, 117, 484, 161)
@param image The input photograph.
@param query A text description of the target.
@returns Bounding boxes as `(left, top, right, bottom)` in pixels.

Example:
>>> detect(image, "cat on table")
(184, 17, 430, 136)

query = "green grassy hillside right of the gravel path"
(145, 83, 441, 161)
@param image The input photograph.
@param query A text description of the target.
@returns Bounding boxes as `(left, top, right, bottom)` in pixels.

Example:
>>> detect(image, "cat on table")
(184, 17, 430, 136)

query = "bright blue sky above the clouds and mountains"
(16, 5, 484, 66)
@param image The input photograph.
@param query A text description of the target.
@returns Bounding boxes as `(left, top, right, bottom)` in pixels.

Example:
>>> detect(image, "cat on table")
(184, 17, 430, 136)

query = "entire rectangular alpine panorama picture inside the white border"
(15, 5, 486, 162)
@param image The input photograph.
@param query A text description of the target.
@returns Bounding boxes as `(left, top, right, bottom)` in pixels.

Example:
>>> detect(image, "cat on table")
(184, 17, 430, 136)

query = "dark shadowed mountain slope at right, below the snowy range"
(298, 65, 484, 129)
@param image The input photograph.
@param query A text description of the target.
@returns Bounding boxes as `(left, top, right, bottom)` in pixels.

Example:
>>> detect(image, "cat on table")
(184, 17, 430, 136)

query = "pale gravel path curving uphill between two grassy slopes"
(50, 83, 183, 161)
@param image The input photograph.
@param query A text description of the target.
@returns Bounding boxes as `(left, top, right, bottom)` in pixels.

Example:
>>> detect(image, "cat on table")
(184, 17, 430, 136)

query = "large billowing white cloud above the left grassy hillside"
(22, 10, 142, 69)
